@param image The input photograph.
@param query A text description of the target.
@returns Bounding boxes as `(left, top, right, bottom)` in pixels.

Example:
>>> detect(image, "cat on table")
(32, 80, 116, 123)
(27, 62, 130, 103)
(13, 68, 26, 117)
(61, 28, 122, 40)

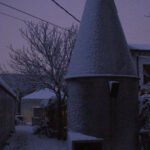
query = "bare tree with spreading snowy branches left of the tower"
(10, 22, 78, 138)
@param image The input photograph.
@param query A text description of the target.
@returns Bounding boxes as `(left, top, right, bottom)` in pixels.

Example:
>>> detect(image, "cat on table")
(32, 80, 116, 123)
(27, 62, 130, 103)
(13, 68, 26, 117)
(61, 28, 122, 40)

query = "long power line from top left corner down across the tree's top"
(0, 2, 67, 30)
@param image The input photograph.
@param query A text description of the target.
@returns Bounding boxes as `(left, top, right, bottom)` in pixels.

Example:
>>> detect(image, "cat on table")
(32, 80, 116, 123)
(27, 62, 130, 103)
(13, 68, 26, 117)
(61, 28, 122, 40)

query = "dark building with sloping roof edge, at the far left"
(0, 80, 16, 149)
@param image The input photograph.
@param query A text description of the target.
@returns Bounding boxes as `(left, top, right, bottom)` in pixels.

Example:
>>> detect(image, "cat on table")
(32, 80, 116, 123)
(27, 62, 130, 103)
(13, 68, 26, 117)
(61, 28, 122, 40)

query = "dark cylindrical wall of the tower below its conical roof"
(68, 77, 138, 150)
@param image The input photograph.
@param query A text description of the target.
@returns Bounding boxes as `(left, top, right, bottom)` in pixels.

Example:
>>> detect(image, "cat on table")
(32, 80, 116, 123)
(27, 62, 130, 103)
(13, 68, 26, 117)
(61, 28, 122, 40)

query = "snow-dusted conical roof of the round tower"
(66, 0, 136, 78)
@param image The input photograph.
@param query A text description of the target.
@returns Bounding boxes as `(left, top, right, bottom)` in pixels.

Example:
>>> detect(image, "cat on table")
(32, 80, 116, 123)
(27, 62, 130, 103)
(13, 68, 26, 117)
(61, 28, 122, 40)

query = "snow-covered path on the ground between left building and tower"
(4, 125, 67, 150)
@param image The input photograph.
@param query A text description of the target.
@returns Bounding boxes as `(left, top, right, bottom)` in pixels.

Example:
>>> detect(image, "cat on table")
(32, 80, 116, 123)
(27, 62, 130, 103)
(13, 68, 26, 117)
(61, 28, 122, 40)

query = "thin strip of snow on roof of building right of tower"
(129, 44, 150, 51)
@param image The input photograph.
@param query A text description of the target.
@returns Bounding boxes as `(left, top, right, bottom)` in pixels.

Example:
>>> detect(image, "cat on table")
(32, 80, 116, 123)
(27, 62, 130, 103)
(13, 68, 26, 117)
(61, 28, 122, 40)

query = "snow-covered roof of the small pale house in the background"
(22, 88, 56, 99)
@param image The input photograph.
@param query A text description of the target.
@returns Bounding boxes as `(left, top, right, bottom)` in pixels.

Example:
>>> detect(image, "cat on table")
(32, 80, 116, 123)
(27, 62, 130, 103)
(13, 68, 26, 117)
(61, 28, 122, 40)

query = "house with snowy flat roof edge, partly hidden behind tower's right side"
(129, 44, 150, 86)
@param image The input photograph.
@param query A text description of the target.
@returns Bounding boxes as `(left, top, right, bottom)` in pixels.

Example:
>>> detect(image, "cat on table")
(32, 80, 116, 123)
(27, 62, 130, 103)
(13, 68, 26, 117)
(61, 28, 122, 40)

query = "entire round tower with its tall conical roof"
(66, 0, 138, 150)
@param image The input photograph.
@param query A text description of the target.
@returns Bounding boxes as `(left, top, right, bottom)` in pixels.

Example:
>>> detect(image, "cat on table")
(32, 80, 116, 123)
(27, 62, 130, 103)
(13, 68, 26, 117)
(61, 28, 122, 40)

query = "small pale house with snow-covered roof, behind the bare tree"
(21, 88, 56, 124)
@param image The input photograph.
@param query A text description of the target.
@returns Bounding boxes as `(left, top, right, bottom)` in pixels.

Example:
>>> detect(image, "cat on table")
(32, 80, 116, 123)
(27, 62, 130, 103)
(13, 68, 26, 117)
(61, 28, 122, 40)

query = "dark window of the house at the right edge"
(143, 64, 150, 84)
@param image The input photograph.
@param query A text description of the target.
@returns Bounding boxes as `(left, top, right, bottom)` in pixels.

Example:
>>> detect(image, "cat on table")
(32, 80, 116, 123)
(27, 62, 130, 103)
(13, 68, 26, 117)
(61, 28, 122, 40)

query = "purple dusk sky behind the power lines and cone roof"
(0, 0, 150, 68)
